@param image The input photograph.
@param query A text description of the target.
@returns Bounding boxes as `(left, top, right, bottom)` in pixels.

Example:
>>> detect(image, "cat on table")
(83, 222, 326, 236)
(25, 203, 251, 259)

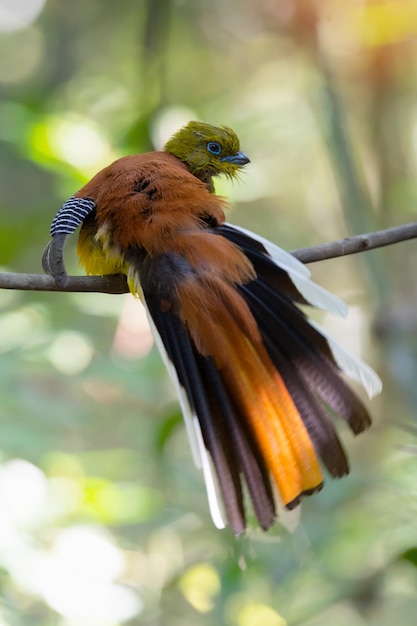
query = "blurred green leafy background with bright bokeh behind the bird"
(0, 0, 417, 626)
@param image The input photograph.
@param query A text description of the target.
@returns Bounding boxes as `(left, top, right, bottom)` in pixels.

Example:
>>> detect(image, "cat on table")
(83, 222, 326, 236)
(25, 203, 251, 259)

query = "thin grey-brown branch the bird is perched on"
(0, 222, 417, 294)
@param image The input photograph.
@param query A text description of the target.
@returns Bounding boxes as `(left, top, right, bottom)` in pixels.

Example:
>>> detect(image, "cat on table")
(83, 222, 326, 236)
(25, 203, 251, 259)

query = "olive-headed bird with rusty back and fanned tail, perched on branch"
(42, 122, 381, 534)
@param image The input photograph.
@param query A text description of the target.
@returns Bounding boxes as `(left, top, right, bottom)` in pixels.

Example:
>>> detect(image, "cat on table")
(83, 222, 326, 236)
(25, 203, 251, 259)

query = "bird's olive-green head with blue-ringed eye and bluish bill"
(164, 122, 249, 187)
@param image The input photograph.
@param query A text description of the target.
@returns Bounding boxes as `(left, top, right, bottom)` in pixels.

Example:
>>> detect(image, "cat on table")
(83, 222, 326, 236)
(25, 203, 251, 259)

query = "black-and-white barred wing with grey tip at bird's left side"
(42, 196, 96, 287)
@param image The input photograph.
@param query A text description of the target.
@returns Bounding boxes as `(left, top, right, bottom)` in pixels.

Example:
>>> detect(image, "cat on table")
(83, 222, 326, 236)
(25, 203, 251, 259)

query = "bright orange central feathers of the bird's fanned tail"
(179, 279, 323, 506)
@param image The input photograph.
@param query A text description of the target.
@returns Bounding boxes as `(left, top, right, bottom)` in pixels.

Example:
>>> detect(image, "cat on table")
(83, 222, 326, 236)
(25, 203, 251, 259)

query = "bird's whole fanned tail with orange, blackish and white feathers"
(130, 226, 378, 534)
